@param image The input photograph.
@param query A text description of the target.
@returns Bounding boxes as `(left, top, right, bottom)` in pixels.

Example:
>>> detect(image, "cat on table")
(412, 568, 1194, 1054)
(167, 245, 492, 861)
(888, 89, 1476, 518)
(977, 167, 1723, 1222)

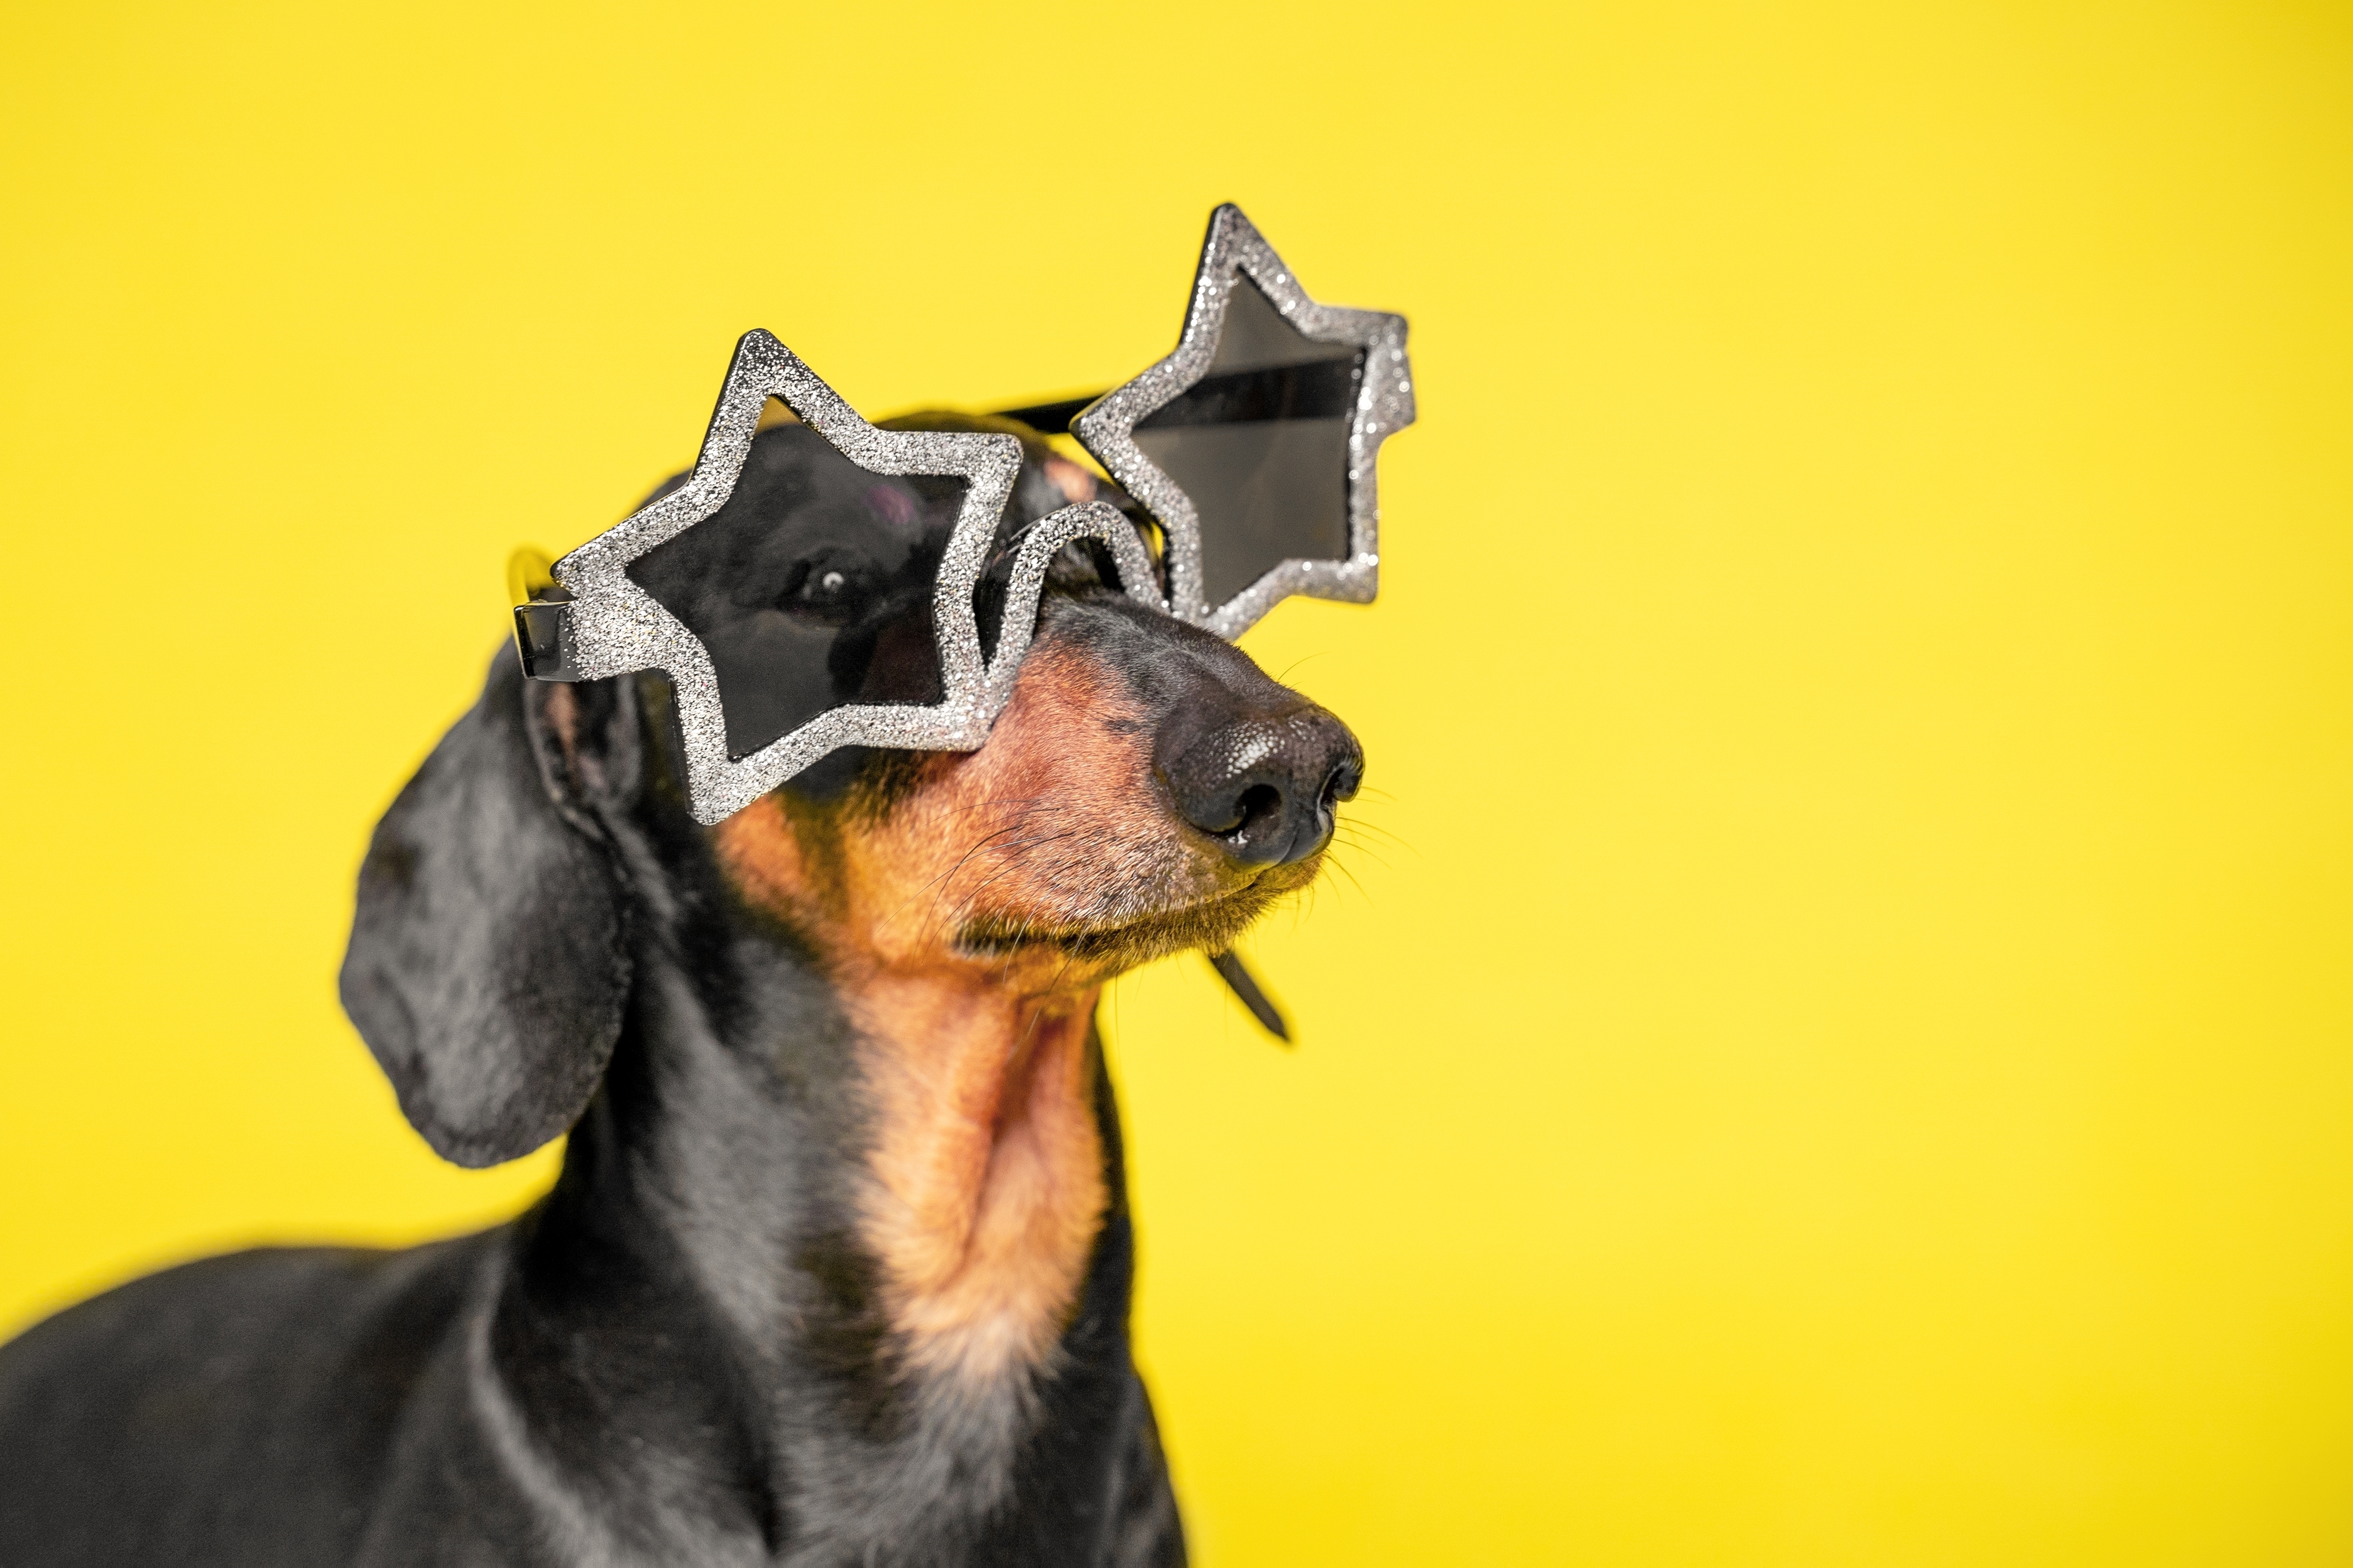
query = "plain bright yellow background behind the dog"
(0, 0, 2353, 1568)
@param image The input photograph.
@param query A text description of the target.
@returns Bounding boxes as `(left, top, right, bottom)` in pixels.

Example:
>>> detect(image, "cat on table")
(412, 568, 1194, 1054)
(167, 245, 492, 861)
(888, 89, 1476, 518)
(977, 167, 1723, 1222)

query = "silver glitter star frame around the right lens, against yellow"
(1071, 202, 1414, 640)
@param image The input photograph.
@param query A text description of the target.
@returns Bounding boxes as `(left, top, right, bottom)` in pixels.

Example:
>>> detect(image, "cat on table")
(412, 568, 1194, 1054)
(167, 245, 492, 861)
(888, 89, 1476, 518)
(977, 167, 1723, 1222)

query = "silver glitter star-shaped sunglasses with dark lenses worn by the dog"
(515, 205, 1414, 822)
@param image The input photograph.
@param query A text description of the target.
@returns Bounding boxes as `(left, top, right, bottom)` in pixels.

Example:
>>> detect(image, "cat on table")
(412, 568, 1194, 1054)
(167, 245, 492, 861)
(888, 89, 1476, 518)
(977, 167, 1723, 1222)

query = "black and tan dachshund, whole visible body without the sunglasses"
(0, 409, 1360, 1568)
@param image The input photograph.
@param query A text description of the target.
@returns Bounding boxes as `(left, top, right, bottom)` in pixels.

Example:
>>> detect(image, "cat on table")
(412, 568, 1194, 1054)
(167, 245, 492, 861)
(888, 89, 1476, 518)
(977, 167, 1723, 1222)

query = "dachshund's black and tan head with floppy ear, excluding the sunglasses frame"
(344, 417, 1362, 1165)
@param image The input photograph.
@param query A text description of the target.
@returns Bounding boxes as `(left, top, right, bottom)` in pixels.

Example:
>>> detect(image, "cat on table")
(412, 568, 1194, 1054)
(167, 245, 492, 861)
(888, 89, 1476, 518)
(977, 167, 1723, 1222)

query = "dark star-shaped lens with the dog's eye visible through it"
(628, 424, 962, 758)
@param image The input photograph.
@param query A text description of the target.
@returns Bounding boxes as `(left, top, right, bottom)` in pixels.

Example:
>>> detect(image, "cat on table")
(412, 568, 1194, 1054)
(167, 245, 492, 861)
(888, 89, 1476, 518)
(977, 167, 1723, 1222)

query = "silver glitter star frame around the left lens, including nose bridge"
(532, 332, 1167, 824)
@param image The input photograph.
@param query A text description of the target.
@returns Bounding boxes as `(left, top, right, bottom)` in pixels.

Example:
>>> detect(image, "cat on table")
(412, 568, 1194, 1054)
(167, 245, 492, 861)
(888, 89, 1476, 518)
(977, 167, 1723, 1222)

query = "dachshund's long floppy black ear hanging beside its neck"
(341, 648, 642, 1165)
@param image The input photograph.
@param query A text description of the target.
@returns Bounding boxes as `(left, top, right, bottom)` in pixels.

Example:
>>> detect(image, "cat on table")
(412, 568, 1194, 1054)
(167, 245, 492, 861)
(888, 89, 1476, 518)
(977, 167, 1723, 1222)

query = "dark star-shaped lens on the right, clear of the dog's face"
(1134, 278, 1362, 608)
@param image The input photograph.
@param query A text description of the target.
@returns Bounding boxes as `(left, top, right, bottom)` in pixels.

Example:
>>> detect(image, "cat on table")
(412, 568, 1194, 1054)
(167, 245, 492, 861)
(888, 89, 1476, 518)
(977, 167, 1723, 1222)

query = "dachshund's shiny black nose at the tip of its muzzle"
(1165, 706, 1365, 866)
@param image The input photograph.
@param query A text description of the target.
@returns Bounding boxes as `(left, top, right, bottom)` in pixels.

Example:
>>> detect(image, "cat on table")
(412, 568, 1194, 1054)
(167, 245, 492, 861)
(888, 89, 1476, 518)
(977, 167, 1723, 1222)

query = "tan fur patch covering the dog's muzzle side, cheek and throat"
(713, 638, 1315, 1377)
